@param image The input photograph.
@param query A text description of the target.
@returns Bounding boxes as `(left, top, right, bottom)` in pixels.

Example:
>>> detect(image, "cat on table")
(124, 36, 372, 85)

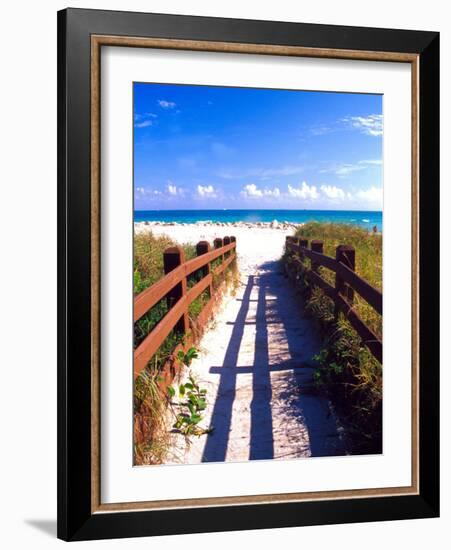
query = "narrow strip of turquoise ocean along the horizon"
(134, 210, 382, 231)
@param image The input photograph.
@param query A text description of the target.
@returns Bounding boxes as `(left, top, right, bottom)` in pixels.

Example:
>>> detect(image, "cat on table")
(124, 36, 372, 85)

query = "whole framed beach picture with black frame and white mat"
(58, 9, 439, 540)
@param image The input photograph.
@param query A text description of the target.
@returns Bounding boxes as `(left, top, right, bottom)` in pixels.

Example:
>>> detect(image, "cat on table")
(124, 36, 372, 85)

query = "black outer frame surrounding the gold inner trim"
(58, 8, 439, 540)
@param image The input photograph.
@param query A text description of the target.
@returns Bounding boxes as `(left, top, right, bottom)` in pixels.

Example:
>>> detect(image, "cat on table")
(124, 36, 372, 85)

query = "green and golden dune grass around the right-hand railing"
(284, 222, 382, 454)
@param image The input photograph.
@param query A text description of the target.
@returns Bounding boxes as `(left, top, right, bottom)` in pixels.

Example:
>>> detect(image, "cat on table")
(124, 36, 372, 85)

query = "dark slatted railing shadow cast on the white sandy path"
(202, 262, 345, 462)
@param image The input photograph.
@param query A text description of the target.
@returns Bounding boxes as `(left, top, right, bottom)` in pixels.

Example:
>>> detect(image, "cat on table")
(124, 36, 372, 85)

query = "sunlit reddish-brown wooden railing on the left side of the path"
(133, 237, 236, 378)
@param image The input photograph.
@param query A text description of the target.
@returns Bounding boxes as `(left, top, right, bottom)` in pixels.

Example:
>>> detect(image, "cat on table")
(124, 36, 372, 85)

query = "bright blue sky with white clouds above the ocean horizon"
(134, 83, 383, 210)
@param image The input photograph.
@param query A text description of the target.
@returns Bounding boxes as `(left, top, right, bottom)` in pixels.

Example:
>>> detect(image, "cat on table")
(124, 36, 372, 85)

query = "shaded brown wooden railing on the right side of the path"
(286, 237, 382, 363)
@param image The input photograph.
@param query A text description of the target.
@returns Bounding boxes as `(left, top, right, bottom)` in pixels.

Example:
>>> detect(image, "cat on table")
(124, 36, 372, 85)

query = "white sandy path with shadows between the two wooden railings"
(166, 236, 345, 464)
